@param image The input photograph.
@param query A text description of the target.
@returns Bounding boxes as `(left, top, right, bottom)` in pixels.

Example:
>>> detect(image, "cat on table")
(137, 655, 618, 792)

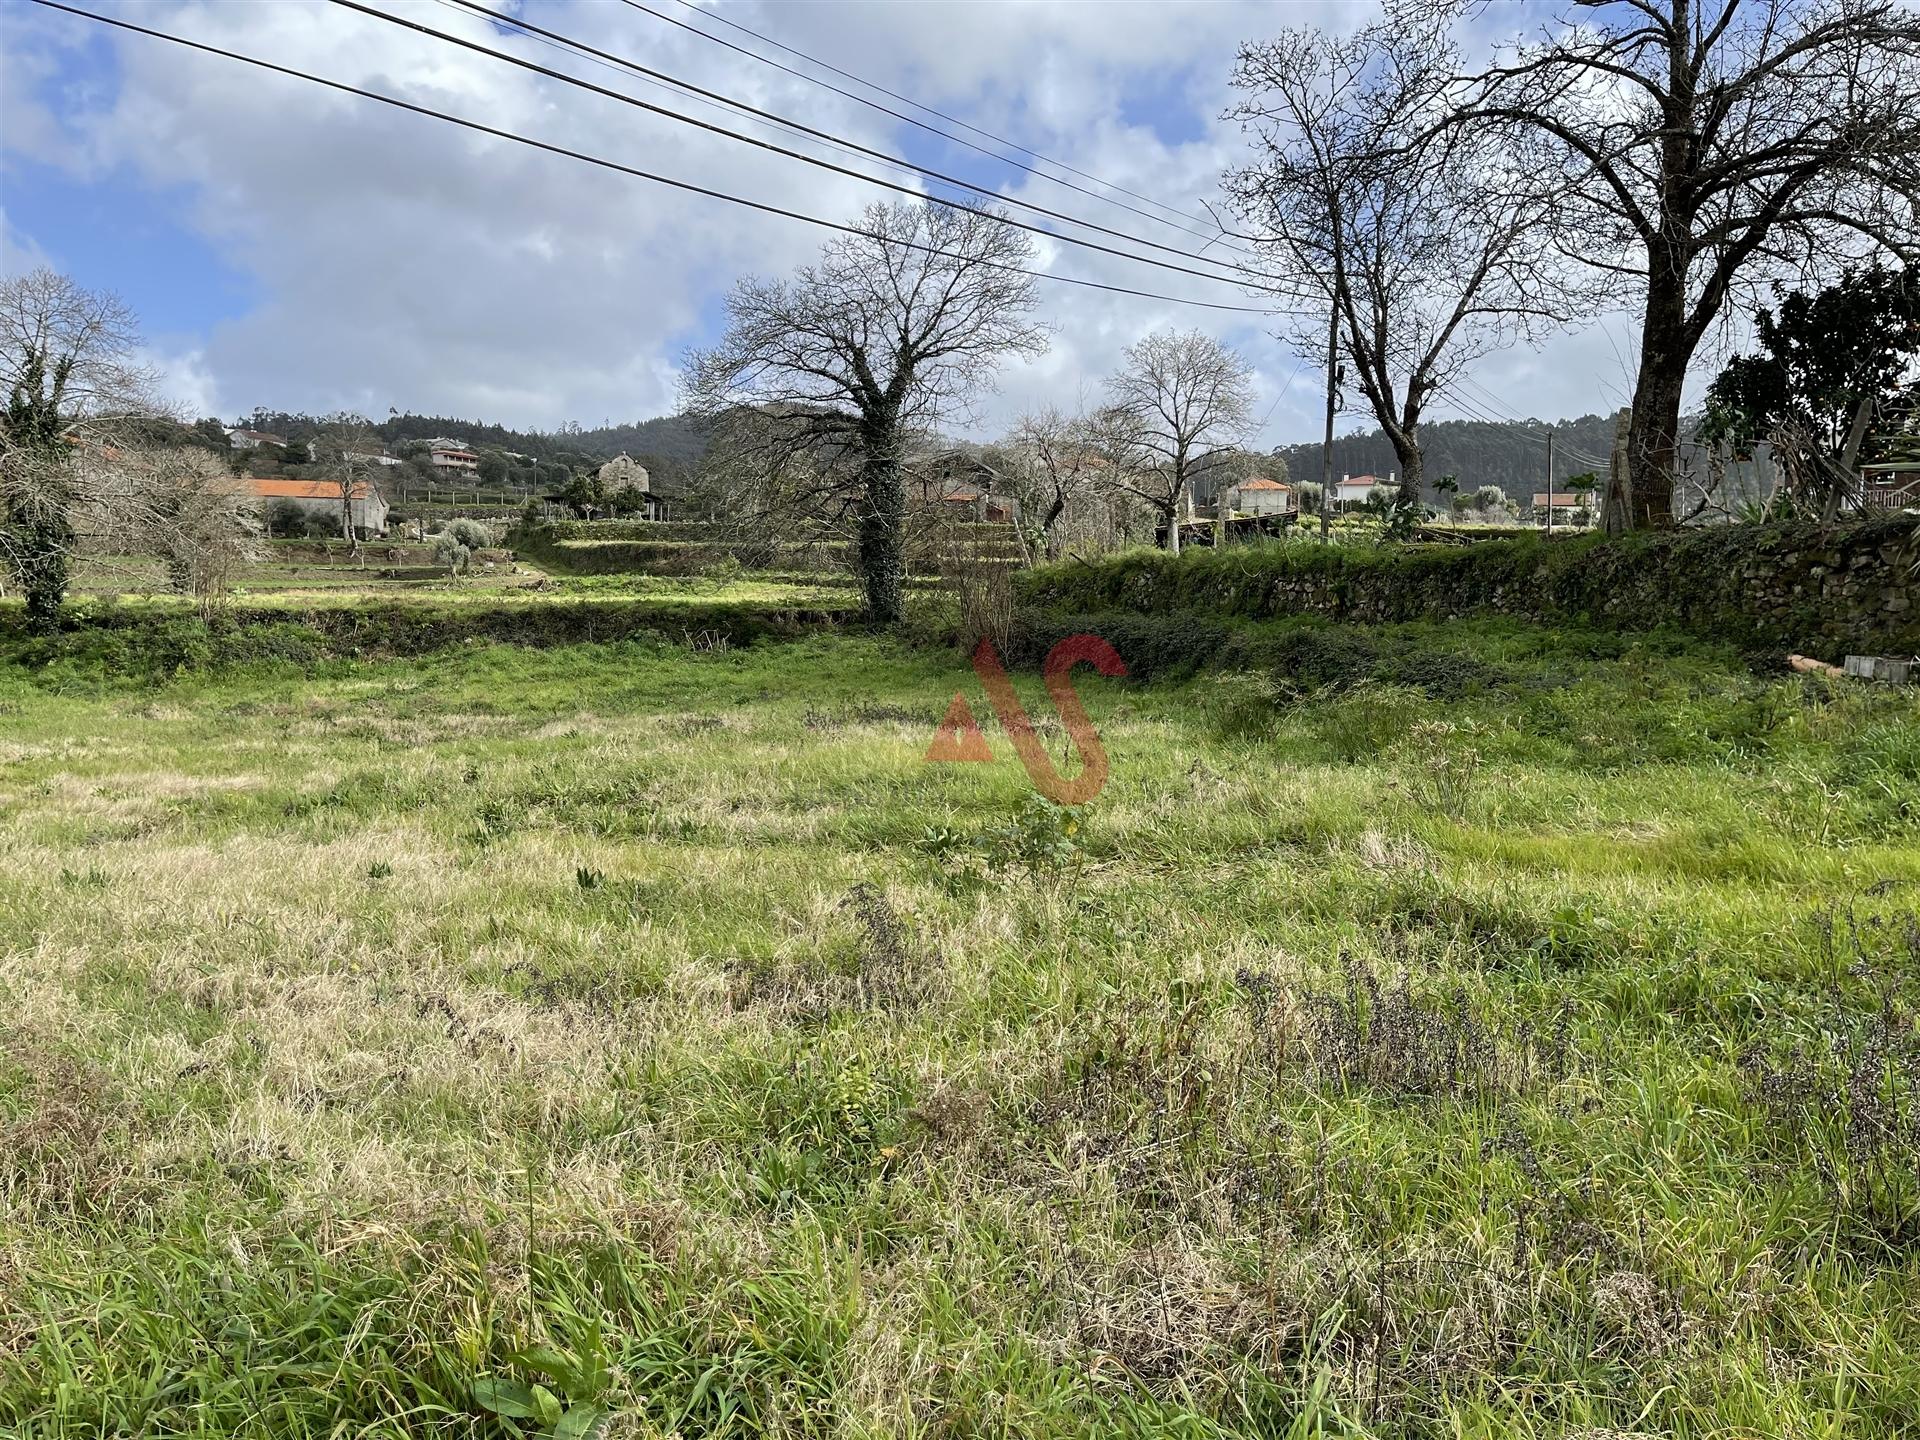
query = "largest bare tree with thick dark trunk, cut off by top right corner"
(1398, 0, 1920, 528)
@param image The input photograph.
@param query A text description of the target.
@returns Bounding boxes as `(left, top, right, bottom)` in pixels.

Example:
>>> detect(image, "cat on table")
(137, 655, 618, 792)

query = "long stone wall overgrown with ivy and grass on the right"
(1018, 516, 1920, 657)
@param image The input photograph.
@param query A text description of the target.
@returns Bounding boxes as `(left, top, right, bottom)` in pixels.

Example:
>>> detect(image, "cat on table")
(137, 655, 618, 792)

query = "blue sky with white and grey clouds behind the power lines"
(0, 0, 1634, 444)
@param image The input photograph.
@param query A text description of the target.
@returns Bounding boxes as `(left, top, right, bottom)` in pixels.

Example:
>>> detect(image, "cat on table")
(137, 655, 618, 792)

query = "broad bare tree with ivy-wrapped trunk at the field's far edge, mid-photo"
(685, 204, 1046, 622)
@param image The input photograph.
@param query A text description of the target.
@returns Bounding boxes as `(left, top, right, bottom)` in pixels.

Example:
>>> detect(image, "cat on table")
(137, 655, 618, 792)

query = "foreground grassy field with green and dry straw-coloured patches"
(0, 591, 1920, 1440)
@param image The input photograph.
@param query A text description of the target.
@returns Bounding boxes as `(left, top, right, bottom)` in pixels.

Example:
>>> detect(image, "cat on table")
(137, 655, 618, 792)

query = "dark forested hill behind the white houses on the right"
(1275, 415, 1613, 499)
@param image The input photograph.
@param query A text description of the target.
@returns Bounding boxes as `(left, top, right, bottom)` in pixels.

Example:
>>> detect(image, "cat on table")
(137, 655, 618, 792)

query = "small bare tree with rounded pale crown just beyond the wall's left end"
(1106, 330, 1254, 555)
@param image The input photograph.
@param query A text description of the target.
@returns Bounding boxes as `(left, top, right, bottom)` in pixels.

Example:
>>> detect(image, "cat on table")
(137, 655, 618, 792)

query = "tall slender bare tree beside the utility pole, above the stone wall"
(1225, 21, 1574, 507)
